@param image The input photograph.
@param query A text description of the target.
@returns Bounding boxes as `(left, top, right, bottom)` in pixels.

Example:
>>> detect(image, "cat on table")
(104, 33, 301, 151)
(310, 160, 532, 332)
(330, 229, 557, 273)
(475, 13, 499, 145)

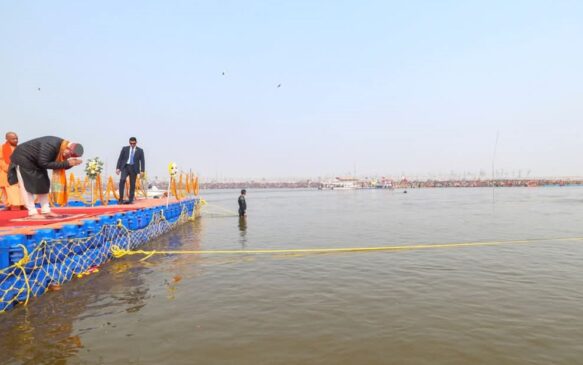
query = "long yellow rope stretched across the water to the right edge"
(111, 237, 583, 260)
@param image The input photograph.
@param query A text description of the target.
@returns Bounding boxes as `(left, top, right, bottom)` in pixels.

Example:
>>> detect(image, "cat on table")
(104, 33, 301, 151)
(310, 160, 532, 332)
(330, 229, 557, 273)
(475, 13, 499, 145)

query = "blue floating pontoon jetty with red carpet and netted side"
(0, 197, 200, 313)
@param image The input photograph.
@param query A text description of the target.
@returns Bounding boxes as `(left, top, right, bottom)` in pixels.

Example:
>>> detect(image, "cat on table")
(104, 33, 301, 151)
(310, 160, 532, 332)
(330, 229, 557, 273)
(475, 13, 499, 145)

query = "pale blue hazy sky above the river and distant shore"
(0, 0, 583, 178)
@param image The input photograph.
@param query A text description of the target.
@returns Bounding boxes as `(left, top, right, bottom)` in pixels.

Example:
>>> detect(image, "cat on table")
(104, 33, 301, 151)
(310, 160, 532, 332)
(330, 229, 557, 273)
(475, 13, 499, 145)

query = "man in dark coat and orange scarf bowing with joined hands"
(8, 136, 83, 219)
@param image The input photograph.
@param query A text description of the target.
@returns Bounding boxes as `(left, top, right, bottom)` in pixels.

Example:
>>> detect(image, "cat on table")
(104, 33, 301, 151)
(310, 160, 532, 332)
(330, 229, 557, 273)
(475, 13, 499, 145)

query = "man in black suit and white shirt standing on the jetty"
(115, 137, 146, 204)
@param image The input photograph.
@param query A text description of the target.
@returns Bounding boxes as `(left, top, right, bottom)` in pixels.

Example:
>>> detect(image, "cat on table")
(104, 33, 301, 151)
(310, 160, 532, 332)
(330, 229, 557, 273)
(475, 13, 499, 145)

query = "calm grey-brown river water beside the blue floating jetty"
(0, 187, 583, 365)
